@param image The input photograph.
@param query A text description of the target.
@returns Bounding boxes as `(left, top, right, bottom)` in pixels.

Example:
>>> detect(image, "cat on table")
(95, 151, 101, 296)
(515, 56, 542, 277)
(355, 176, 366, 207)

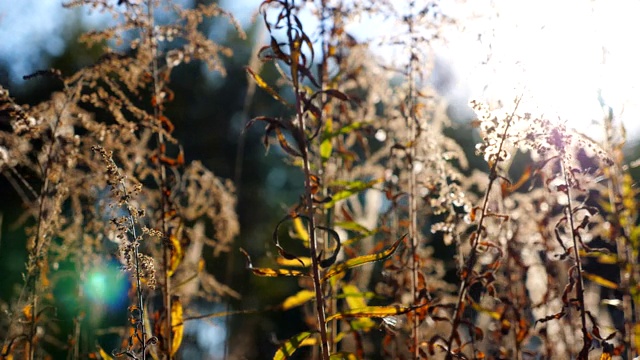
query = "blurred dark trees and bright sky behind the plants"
(0, 0, 640, 359)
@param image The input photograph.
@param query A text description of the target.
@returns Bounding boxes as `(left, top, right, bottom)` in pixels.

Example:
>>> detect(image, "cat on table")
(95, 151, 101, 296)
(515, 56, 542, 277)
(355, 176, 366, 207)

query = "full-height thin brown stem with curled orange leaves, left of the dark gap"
(147, 0, 173, 358)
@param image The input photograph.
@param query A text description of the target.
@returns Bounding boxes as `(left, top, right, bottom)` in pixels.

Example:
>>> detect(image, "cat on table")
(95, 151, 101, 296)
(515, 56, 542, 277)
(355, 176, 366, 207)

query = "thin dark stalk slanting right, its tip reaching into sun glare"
(445, 97, 522, 360)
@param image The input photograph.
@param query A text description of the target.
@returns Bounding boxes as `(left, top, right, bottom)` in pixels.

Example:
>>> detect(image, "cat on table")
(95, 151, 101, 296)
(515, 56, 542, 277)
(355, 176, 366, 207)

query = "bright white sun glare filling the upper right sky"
(443, 0, 640, 138)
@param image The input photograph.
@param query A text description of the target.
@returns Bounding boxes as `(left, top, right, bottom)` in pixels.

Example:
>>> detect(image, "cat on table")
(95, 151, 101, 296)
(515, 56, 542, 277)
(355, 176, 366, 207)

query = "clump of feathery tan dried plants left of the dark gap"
(1, 0, 239, 359)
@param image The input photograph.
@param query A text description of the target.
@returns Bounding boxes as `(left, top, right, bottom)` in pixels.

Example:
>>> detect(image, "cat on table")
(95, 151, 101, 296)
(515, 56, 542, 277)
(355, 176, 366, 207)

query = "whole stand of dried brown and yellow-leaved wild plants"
(0, 0, 640, 360)
